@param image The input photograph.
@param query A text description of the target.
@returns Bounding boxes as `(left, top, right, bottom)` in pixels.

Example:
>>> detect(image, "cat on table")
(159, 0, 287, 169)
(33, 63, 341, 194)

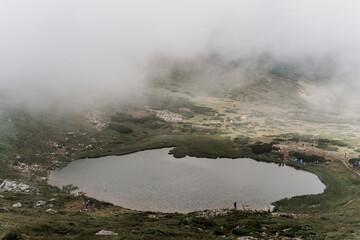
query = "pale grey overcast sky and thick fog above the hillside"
(0, 0, 360, 107)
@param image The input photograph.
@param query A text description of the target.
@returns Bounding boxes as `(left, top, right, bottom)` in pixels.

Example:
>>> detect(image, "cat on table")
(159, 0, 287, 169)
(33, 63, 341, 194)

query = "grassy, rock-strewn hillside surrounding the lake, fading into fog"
(0, 59, 360, 239)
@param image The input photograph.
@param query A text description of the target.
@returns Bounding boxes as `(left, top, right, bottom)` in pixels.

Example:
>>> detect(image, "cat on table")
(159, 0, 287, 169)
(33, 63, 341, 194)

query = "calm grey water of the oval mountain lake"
(49, 148, 325, 212)
